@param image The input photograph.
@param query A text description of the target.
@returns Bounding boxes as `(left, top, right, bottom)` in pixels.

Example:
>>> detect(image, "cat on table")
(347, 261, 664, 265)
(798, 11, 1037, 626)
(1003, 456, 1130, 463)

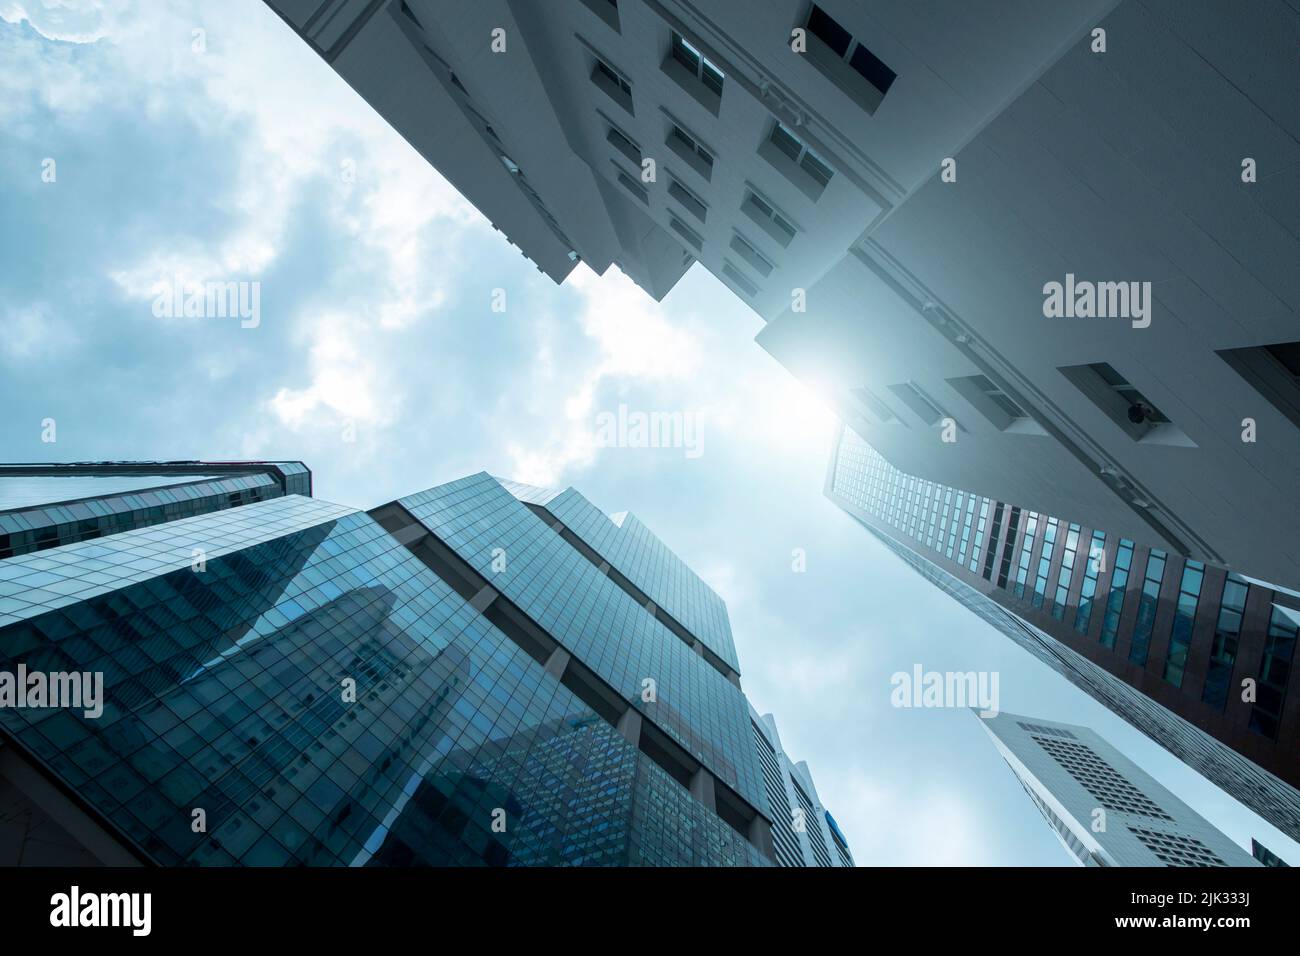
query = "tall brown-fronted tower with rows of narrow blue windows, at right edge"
(826, 428, 1300, 838)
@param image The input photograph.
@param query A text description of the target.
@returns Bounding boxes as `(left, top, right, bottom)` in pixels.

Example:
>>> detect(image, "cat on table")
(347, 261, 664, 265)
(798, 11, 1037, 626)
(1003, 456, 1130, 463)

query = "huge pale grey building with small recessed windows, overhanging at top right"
(268, 0, 1300, 587)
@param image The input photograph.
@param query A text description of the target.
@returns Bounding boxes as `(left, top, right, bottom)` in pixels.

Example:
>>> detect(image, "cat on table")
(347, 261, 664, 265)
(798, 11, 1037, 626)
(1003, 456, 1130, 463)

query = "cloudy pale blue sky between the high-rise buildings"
(0, 0, 1300, 866)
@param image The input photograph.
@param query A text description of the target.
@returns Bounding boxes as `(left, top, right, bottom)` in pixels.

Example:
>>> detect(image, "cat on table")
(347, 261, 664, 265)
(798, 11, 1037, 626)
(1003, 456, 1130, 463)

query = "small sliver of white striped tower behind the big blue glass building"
(749, 705, 854, 866)
